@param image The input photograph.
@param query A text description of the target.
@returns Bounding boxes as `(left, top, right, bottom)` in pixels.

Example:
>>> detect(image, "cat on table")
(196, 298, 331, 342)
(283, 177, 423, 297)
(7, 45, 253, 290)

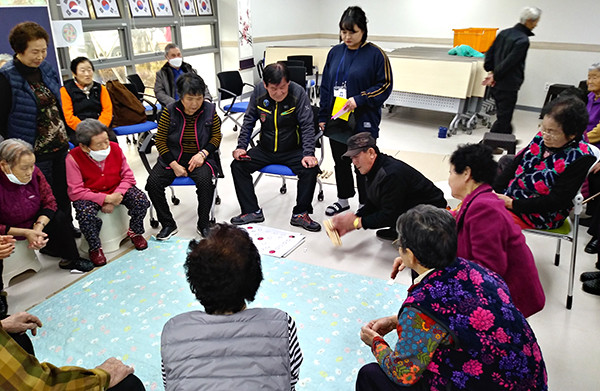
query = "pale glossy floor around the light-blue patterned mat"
(7, 108, 600, 391)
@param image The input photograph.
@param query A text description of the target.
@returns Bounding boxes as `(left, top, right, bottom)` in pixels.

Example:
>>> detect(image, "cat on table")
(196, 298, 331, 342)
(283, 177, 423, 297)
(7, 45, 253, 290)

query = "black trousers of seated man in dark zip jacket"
(231, 147, 319, 214)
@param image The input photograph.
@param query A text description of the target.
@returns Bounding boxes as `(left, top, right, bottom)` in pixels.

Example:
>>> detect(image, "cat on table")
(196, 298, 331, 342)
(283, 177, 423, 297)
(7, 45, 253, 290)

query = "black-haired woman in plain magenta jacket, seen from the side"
(448, 144, 546, 317)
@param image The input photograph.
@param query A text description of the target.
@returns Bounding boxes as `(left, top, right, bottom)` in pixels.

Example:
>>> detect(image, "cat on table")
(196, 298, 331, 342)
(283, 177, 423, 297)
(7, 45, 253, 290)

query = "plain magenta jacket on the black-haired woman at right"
(456, 184, 546, 317)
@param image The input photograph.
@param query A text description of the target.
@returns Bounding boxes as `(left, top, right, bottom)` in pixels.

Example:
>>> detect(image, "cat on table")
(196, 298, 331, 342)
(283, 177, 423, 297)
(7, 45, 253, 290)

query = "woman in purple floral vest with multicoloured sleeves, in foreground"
(356, 205, 548, 391)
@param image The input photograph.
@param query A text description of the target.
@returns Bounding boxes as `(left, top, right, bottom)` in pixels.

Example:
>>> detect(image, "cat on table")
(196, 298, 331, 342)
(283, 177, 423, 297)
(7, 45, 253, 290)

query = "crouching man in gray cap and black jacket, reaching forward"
(332, 132, 447, 240)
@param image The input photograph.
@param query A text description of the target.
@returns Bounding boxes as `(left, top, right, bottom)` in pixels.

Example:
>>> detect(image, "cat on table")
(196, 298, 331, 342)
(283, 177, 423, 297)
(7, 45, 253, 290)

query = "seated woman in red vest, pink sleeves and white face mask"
(66, 119, 150, 266)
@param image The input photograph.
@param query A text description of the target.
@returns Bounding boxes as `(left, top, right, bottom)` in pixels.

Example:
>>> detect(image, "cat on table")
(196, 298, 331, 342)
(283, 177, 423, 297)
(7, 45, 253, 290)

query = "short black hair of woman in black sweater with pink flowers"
(542, 95, 589, 140)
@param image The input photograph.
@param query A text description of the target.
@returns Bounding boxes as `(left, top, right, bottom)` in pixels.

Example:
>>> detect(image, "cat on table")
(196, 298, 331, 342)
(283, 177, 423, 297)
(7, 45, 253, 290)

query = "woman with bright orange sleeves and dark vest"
(60, 57, 117, 145)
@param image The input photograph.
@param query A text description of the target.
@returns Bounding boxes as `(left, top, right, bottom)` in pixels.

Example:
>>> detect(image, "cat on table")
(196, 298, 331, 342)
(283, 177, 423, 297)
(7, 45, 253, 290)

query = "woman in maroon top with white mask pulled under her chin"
(0, 139, 94, 315)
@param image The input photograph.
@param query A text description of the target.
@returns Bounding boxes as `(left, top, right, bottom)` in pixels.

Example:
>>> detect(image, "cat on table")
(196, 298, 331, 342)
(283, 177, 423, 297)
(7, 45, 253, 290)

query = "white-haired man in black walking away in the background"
(482, 7, 542, 134)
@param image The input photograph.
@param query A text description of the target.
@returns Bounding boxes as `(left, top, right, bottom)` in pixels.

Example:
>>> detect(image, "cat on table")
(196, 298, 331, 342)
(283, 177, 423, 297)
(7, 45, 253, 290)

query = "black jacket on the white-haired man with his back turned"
(483, 23, 534, 91)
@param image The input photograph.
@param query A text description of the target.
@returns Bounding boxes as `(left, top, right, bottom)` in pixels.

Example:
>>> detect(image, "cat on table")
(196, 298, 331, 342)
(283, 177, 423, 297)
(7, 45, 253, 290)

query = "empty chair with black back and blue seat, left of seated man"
(217, 71, 254, 132)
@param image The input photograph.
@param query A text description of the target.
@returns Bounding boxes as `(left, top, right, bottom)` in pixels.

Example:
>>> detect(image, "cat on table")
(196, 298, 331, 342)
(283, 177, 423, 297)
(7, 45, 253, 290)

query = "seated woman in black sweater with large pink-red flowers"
(494, 96, 596, 229)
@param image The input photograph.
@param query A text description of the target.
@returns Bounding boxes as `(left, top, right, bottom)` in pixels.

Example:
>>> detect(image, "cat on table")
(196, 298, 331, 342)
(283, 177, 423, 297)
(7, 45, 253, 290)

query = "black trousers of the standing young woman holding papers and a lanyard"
(329, 138, 367, 204)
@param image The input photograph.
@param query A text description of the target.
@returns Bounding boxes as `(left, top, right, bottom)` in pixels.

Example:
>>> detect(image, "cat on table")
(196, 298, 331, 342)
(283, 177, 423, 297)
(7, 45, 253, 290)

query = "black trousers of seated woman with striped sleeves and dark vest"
(146, 161, 215, 229)
